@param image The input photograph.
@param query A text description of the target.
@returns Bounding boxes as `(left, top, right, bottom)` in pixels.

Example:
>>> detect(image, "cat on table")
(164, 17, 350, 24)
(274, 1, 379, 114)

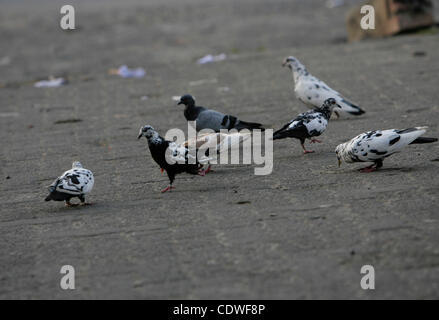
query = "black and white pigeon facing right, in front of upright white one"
(273, 98, 338, 154)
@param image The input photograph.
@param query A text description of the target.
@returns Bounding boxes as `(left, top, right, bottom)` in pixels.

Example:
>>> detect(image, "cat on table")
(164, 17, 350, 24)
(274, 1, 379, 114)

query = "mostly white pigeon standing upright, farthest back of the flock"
(282, 57, 365, 117)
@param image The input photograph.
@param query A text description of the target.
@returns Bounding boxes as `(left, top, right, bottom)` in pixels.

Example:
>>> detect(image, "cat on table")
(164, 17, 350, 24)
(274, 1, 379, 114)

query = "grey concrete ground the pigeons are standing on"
(0, 0, 439, 299)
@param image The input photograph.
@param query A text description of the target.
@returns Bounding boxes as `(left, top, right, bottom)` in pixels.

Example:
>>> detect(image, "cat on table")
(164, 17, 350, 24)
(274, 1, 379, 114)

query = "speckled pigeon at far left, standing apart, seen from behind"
(45, 161, 94, 207)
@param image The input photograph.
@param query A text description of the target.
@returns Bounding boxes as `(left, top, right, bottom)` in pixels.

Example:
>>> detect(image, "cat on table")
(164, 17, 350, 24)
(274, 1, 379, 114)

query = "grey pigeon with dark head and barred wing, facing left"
(178, 94, 264, 132)
